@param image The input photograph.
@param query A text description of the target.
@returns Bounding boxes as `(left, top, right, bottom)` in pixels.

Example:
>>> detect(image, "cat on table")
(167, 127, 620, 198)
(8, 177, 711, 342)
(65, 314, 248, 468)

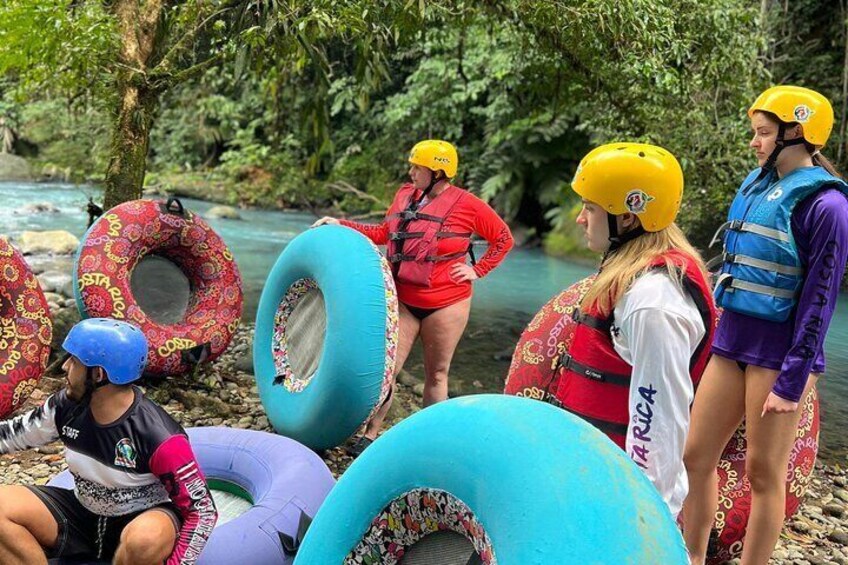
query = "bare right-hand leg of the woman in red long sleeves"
(421, 298, 471, 406)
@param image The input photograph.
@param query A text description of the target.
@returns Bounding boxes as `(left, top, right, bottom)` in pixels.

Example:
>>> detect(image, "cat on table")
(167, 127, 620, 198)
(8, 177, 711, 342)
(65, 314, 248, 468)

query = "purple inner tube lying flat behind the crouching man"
(49, 427, 336, 565)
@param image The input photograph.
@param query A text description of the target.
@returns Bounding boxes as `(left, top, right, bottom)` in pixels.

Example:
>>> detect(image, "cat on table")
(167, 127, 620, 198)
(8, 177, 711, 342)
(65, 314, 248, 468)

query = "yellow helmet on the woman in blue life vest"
(748, 86, 833, 147)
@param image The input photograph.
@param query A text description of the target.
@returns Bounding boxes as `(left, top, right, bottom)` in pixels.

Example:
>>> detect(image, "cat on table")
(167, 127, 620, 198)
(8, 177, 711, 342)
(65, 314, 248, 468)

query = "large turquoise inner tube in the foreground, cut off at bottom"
(295, 395, 688, 565)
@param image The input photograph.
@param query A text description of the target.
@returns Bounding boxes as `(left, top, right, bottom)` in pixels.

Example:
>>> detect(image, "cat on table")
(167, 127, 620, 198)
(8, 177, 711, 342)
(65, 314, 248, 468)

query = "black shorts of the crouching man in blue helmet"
(27, 486, 181, 561)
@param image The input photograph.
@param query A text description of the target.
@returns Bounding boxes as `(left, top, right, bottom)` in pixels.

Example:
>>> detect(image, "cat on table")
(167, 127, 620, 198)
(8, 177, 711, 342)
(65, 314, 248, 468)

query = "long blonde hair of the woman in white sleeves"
(580, 224, 707, 316)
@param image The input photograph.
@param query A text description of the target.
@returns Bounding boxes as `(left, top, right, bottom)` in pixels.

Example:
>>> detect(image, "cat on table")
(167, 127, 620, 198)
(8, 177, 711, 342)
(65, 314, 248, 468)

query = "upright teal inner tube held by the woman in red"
(253, 225, 398, 449)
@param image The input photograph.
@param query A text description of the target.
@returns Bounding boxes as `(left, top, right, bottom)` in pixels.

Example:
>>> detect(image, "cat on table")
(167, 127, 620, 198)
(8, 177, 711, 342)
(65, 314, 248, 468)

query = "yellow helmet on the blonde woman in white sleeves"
(571, 143, 683, 232)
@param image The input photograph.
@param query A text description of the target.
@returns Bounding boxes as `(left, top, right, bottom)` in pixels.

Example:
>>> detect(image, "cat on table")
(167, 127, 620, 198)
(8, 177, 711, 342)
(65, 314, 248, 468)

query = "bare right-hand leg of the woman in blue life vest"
(742, 365, 818, 565)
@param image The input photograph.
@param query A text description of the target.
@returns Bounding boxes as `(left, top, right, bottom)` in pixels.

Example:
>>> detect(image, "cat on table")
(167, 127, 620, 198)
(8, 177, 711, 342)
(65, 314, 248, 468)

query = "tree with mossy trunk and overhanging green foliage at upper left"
(0, 0, 430, 208)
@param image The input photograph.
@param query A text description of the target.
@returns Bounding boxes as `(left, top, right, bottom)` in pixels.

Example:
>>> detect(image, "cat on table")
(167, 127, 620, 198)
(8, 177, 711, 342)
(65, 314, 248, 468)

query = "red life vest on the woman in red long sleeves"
(386, 184, 472, 287)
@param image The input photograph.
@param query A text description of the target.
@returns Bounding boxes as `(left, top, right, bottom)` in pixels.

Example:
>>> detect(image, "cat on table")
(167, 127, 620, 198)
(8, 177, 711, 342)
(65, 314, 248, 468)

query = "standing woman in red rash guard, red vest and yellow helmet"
(313, 139, 513, 456)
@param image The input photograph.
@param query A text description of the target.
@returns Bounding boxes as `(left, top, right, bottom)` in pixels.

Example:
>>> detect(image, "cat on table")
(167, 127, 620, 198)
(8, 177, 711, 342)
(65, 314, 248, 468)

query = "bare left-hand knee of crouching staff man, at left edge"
(0, 485, 59, 565)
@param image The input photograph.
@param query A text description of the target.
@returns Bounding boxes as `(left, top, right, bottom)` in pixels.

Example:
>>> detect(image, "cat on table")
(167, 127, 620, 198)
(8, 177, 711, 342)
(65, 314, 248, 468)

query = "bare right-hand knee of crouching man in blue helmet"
(112, 509, 177, 565)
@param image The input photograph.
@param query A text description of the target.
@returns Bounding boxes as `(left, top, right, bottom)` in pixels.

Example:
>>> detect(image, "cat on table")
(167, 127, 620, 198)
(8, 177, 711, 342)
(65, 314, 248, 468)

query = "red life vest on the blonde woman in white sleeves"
(548, 251, 716, 449)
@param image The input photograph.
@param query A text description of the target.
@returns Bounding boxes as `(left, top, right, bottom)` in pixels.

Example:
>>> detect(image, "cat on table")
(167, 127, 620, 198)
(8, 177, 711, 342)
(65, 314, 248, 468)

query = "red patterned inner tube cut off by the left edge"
(0, 237, 53, 418)
